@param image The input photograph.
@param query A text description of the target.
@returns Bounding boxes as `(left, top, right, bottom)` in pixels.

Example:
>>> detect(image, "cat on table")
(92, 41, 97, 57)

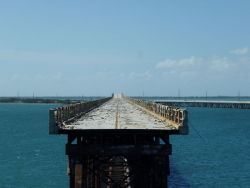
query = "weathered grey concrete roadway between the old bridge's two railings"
(64, 95, 176, 130)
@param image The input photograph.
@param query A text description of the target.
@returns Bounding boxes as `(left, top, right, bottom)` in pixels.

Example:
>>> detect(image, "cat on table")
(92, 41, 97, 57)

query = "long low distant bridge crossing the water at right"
(154, 100, 250, 109)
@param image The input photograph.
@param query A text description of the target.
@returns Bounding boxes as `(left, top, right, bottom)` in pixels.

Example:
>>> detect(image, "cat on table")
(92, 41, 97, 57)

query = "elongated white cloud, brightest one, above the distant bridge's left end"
(156, 56, 202, 68)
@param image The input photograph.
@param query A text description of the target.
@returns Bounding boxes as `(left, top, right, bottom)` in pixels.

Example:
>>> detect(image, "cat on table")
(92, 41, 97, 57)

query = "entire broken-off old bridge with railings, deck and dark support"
(49, 94, 188, 188)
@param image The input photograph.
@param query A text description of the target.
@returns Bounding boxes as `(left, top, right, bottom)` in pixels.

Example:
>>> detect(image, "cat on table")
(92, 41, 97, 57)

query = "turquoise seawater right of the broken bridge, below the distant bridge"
(169, 108, 250, 188)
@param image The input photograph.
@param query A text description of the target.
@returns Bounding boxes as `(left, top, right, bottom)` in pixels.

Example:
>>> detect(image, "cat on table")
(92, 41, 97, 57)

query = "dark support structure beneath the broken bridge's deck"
(66, 134, 171, 188)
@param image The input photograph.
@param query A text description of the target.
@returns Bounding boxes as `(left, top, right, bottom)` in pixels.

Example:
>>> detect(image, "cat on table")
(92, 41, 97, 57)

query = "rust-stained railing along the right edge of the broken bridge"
(126, 98, 188, 134)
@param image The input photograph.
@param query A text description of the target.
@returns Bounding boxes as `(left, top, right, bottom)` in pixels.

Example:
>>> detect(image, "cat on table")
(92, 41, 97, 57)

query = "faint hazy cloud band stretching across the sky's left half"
(0, 50, 134, 66)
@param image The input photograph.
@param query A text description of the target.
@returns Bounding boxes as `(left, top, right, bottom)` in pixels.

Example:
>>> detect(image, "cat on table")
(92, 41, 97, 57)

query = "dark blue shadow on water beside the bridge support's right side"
(168, 161, 191, 188)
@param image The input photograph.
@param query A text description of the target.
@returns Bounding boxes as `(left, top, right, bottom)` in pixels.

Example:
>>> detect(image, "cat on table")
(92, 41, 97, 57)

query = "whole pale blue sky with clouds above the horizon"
(0, 0, 250, 96)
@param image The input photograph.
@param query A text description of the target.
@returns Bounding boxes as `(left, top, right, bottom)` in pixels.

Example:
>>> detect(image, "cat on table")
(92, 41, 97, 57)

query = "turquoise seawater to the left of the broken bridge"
(0, 104, 68, 188)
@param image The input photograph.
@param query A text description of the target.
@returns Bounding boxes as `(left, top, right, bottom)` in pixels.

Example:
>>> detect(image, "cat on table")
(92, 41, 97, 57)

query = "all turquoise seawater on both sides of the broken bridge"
(0, 104, 250, 188)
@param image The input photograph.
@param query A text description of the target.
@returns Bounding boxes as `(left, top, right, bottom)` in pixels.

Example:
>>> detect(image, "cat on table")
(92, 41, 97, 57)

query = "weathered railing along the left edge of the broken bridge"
(49, 97, 111, 134)
